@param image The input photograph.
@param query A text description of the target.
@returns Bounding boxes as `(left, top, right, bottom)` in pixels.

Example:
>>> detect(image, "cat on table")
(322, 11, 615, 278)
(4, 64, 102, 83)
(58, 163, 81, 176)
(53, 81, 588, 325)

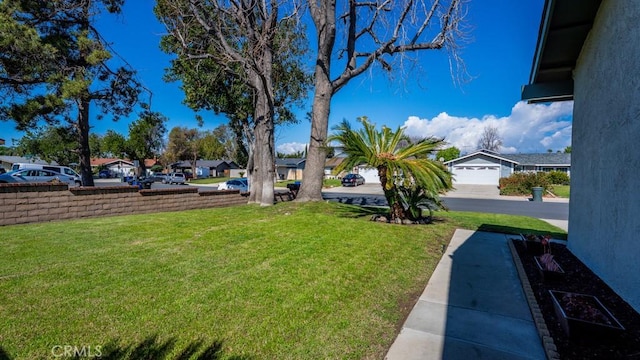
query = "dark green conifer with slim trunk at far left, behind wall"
(0, 0, 141, 186)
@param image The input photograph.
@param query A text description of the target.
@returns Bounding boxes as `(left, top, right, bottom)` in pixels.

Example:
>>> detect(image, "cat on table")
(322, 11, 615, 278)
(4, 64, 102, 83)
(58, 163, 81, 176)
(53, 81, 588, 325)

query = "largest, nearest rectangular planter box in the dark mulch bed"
(549, 290, 624, 339)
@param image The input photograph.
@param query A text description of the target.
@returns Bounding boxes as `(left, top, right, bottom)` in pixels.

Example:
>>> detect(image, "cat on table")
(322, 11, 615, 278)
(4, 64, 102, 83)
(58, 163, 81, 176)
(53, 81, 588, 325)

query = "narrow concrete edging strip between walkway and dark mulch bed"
(507, 237, 560, 360)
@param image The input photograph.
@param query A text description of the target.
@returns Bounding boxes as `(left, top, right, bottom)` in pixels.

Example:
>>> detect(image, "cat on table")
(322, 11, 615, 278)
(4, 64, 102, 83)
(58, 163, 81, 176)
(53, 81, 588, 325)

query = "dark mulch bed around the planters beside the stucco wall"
(513, 240, 640, 360)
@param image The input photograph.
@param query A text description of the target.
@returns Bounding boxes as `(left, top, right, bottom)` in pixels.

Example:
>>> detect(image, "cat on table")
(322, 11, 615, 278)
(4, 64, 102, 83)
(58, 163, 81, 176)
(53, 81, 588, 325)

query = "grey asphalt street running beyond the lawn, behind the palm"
(323, 192, 569, 220)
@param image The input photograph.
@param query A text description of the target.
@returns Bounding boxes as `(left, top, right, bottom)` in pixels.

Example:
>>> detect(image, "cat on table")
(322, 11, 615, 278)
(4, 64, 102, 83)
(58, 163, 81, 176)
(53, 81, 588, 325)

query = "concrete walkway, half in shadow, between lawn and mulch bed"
(386, 230, 546, 360)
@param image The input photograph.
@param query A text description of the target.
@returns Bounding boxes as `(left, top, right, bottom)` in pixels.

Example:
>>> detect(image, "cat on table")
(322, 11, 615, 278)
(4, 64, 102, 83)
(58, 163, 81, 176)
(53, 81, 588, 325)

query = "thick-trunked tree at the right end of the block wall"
(155, 0, 312, 205)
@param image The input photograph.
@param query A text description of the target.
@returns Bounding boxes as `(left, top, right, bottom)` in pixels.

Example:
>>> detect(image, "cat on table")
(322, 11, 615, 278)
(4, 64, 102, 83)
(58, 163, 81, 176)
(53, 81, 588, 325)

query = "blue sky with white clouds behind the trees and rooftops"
(0, 0, 573, 153)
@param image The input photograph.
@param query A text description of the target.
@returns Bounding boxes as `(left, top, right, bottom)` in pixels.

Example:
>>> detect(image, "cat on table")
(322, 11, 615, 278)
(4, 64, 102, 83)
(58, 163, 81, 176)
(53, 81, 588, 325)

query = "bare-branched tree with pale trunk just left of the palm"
(297, 0, 464, 201)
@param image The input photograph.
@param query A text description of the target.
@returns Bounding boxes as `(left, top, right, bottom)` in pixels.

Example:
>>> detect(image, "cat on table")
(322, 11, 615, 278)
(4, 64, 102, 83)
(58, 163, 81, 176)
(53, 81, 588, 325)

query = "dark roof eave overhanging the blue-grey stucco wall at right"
(522, 0, 602, 102)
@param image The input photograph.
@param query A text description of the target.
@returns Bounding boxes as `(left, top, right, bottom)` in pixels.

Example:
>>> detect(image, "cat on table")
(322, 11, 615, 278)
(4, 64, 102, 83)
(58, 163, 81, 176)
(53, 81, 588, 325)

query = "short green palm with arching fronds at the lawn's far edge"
(328, 117, 452, 221)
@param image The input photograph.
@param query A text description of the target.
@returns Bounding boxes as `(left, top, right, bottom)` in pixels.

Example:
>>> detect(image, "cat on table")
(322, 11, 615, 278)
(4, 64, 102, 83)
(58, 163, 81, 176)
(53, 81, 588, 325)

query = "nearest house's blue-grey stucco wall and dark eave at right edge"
(522, 0, 640, 311)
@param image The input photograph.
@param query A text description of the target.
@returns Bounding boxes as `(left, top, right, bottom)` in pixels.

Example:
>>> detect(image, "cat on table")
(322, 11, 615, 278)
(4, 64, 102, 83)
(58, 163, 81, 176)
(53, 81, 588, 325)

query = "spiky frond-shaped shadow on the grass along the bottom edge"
(0, 335, 252, 360)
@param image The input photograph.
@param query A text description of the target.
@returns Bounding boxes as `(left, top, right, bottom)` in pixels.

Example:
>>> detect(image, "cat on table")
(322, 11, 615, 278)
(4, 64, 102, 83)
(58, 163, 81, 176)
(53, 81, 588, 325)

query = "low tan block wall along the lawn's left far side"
(0, 183, 248, 225)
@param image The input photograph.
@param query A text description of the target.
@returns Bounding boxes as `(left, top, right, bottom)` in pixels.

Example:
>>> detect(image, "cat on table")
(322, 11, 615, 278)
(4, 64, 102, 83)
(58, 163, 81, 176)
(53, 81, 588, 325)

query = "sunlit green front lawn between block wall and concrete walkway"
(0, 202, 562, 359)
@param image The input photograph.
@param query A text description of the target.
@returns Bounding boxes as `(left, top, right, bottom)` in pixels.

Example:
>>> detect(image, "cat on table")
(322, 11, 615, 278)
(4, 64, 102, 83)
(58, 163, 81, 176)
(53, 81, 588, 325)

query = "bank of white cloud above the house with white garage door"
(403, 101, 573, 153)
